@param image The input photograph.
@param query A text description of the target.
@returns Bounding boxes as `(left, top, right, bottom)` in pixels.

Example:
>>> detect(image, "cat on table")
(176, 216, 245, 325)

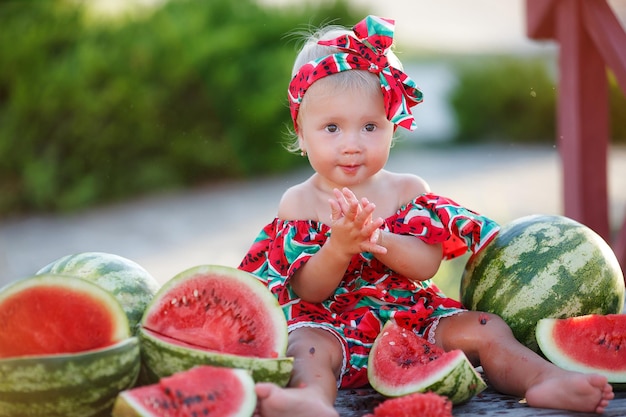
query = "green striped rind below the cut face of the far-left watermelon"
(0, 337, 140, 417)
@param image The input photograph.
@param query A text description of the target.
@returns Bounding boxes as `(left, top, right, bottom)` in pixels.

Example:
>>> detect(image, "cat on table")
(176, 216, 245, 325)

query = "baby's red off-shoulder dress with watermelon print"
(239, 194, 499, 388)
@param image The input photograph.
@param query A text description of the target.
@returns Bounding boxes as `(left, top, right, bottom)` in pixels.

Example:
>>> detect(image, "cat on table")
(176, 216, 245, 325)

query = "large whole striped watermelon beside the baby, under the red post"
(461, 215, 625, 352)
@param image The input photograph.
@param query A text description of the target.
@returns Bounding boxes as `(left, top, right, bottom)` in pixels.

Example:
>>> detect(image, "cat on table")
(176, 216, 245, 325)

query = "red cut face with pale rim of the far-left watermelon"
(0, 275, 130, 358)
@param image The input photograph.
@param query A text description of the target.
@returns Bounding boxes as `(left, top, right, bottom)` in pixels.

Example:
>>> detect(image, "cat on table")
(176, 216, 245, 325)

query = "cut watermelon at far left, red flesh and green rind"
(0, 274, 140, 417)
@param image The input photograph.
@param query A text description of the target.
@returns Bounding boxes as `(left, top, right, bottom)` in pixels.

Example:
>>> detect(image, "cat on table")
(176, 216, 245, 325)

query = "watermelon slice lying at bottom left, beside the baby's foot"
(112, 366, 256, 417)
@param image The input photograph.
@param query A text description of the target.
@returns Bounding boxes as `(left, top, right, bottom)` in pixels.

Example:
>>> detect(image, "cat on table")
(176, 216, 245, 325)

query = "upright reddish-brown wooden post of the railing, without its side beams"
(556, 0, 611, 237)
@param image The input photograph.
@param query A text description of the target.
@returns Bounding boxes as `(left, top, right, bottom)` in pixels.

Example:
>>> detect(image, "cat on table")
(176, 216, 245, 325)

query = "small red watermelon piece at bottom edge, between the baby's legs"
(363, 392, 452, 417)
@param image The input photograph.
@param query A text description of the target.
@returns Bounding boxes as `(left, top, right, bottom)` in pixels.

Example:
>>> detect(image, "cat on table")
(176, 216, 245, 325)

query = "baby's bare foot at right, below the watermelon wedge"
(526, 372, 615, 414)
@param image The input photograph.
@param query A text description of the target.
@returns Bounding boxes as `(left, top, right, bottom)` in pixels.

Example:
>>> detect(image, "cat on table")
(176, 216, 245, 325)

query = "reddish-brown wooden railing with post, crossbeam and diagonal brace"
(526, 0, 626, 272)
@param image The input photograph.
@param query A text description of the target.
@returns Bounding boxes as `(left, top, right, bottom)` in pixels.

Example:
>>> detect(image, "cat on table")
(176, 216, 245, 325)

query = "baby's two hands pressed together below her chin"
(329, 188, 387, 255)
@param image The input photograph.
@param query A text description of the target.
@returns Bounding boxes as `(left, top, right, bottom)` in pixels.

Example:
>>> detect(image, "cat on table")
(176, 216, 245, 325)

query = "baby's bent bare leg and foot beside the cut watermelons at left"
(255, 327, 343, 417)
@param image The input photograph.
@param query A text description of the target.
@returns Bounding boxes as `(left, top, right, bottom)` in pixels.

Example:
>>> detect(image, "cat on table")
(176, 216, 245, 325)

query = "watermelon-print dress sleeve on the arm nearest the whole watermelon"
(389, 193, 500, 259)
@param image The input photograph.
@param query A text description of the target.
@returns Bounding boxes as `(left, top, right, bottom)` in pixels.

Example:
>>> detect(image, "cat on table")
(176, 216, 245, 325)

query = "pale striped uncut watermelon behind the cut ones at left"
(37, 252, 160, 334)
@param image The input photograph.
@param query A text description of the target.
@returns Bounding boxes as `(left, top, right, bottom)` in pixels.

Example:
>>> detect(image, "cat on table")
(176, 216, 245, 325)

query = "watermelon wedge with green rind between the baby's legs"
(367, 320, 487, 404)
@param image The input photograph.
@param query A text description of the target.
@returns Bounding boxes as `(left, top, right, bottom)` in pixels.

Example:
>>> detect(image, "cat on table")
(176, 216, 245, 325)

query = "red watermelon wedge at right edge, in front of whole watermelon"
(537, 314, 626, 383)
